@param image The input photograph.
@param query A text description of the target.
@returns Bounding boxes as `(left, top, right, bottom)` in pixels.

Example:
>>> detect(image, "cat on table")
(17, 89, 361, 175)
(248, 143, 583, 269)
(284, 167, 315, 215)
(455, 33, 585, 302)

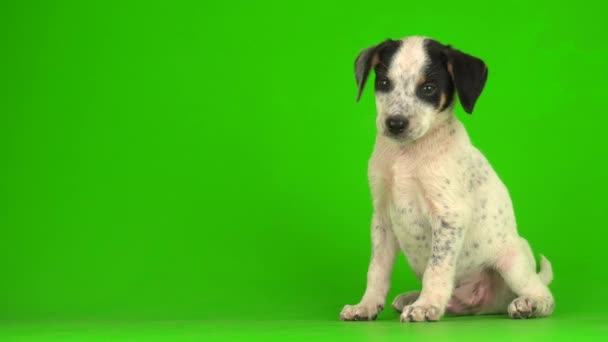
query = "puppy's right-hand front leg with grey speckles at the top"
(401, 215, 465, 322)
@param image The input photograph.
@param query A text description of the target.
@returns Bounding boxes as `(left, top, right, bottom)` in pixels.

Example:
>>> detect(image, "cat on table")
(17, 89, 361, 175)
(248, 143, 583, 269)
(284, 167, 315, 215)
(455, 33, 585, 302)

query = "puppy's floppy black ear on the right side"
(446, 47, 488, 114)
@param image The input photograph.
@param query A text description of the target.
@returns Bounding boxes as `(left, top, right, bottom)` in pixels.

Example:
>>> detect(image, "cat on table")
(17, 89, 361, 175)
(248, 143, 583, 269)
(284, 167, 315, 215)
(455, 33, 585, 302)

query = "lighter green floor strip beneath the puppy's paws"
(0, 313, 608, 342)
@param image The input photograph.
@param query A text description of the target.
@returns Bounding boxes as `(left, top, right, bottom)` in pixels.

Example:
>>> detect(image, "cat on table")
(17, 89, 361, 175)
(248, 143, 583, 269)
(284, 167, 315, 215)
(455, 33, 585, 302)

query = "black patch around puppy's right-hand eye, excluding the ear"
(416, 39, 454, 112)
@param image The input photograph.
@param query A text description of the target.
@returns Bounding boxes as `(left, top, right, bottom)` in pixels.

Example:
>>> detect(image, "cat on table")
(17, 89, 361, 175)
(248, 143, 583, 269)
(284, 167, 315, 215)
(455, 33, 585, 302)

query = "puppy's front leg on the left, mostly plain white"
(340, 214, 398, 321)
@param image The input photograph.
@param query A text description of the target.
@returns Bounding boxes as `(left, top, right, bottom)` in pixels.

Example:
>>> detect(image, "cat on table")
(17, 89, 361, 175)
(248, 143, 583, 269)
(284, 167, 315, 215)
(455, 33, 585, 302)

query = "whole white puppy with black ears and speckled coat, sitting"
(340, 37, 554, 322)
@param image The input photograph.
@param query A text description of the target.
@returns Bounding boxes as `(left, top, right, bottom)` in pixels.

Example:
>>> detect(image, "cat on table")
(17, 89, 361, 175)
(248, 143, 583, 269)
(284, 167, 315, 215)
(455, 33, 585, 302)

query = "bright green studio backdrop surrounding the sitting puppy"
(0, 1, 608, 340)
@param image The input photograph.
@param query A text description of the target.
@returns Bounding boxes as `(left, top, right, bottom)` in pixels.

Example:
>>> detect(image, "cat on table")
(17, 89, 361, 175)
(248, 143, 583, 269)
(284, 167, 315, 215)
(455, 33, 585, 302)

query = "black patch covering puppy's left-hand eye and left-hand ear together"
(355, 39, 402, 101)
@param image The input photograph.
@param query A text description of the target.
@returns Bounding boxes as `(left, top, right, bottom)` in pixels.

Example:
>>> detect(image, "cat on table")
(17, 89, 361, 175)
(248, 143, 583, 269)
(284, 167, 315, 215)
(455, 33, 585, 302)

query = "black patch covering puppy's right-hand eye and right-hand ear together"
(416, 39, 488, 113)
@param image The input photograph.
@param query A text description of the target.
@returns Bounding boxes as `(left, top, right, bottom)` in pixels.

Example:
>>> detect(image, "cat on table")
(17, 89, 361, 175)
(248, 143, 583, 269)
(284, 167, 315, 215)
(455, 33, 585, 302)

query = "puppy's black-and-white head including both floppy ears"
(355, 37, 488, 141)
